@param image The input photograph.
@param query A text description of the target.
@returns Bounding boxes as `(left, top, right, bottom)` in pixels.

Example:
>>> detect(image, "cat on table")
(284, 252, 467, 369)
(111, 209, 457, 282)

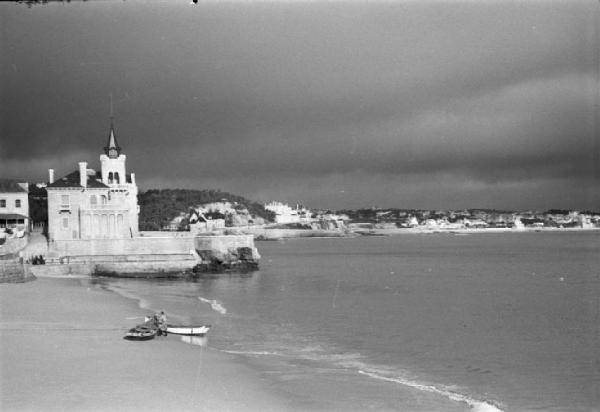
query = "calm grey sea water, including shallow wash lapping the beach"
(100, 232, 600, 412)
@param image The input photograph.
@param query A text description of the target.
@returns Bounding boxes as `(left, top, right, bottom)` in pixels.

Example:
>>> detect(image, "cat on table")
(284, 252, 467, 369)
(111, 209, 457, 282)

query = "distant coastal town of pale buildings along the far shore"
(141, 196, 600, 234)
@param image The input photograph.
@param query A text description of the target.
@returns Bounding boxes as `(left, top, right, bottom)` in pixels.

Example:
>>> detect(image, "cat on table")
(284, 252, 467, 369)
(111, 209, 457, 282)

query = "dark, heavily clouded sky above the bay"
(0, 0, 600, 210)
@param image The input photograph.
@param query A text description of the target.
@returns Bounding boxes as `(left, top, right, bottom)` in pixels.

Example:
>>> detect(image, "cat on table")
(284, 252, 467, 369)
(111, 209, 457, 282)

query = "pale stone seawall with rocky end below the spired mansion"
(41, 232, 260, 276)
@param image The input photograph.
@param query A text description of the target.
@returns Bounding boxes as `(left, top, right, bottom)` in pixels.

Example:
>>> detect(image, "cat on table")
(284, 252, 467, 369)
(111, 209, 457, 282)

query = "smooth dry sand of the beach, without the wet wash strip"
(0, 278, 289, 411)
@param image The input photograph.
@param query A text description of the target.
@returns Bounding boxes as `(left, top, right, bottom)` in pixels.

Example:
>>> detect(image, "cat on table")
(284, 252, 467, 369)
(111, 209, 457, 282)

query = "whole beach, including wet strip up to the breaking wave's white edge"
(0, 276, 474, 411)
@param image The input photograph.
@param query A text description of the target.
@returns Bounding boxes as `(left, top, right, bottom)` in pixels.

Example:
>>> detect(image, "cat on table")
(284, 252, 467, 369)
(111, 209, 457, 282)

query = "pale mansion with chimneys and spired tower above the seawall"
(46, 122, 139, 241)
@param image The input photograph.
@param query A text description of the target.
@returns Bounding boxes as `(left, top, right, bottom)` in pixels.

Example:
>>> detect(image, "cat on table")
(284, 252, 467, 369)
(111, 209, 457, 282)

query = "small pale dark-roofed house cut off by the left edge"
(0, 179, 30, 232)
